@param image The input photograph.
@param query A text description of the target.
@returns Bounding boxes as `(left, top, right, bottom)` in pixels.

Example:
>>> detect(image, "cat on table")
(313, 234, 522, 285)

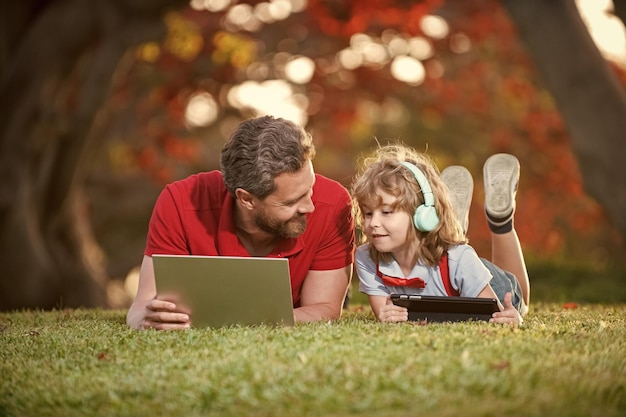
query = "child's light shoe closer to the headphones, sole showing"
(441, 165, 474, 232)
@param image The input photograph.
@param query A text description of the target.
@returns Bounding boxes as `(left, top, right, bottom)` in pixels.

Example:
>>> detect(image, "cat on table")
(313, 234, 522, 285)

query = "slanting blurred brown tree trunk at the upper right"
(503, 0, 626, 239)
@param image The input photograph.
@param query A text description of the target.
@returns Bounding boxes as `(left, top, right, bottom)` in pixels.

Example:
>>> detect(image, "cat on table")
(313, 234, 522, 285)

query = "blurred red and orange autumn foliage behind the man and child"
(107, 0, 626, 257)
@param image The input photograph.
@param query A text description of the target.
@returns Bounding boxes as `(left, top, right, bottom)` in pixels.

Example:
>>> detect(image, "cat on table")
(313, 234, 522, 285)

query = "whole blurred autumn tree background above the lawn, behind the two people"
(0, 0, 626, 310)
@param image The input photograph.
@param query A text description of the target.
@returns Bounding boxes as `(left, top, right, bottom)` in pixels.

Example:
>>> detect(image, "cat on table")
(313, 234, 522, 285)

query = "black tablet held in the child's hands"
(391, 294, 500, 322)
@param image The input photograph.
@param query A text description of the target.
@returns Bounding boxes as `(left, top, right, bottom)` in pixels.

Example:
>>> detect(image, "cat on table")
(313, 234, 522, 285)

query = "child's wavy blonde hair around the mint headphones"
(352, 143, 467, 266)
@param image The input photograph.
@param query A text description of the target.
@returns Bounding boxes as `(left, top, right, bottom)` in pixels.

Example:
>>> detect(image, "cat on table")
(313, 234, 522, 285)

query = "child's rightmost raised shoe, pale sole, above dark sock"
(483, 153, 520, 218)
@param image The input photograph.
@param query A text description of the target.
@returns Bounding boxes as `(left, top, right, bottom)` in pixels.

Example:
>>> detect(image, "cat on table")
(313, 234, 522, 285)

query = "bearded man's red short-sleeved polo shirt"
(144, 171, 354, 307)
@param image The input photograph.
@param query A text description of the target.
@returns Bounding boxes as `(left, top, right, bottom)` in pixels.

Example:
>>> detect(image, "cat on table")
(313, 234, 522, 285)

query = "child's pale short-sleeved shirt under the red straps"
(355, 243, 492, 297)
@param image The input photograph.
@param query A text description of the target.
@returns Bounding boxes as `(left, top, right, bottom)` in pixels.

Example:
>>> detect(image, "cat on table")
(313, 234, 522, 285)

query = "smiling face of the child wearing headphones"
(361, 189, 413, 254)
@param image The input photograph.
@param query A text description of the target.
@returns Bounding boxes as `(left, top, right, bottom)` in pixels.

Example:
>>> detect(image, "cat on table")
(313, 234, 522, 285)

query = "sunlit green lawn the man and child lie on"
(0, 303, 626, 417)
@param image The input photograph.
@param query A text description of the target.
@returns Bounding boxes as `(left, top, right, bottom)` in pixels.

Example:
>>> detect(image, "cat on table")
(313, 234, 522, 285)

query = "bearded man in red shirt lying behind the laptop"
(126, 116, 354, 330)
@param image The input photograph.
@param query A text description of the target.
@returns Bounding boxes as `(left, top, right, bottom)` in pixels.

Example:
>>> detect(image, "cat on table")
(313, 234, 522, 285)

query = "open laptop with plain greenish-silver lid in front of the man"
(152, 255, 294, 328)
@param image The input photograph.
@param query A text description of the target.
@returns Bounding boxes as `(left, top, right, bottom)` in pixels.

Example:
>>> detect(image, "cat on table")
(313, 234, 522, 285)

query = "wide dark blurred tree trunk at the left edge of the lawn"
(0, 0, 188, 310)
